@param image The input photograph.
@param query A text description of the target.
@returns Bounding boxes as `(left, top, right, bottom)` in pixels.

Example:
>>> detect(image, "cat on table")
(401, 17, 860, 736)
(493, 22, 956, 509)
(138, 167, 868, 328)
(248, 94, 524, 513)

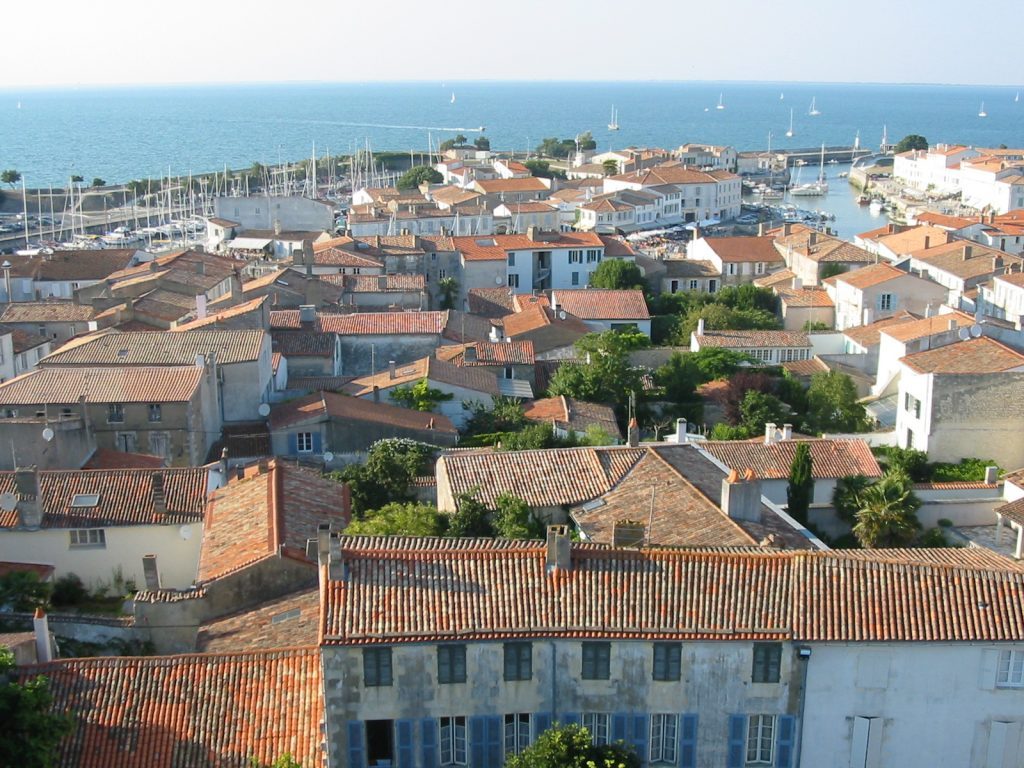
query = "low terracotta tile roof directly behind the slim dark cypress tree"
(700, 438, 882, 480)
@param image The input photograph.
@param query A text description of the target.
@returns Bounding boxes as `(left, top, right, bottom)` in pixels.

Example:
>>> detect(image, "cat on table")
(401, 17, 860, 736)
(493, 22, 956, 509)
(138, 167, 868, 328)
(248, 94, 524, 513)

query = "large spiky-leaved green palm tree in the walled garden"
(853, 472, 921, 548)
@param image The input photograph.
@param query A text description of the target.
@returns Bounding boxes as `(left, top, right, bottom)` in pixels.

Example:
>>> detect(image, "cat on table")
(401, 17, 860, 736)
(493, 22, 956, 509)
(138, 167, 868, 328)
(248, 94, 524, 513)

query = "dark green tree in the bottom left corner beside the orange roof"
(0, 648, 74, 768)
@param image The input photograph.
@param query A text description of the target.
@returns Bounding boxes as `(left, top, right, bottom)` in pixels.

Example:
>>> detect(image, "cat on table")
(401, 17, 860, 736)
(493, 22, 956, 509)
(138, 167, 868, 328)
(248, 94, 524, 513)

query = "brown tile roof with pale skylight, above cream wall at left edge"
(0, 467, 208, 528)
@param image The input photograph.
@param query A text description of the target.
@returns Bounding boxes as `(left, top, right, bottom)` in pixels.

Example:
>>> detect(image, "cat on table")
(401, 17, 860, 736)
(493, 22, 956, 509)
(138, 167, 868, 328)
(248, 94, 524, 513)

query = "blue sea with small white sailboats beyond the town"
(0, 82, 1024, 186)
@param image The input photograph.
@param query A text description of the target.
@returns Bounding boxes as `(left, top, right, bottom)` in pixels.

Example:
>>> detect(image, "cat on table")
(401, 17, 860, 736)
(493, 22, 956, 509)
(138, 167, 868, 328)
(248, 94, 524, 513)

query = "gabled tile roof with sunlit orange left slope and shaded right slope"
(199, 459, 349, 582)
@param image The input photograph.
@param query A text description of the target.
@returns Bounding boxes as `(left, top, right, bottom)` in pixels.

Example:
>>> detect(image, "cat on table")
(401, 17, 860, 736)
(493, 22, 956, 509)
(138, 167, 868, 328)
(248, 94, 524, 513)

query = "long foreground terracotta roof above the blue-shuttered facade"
(322, 537, 1024, 645)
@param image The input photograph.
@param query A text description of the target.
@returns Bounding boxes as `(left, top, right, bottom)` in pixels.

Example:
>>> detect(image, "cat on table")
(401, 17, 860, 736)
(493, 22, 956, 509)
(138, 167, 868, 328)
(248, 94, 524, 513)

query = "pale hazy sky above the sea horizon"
(0, 0, 1024, 88)
